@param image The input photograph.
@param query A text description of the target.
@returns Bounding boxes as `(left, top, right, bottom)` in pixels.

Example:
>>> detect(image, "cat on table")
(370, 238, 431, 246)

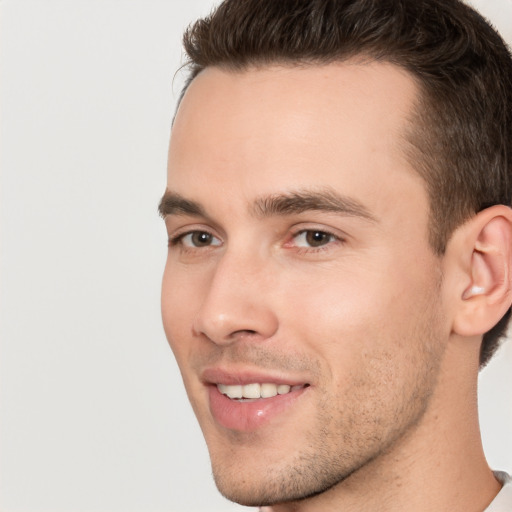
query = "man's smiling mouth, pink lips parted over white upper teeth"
(202, 369, 310, 432)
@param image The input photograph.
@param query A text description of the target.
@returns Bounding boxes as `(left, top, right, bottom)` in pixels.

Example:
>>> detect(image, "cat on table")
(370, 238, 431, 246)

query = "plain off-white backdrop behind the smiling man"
(0, 0, 512, 512)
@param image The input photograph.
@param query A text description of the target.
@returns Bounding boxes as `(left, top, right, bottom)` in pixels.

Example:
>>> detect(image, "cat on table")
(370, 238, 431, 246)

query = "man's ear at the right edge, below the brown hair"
(447, 205, 512, 336)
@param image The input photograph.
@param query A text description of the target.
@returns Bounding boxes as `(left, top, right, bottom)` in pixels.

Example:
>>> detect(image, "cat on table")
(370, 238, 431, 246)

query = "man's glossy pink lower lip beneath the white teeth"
(209, 385, 308, 432)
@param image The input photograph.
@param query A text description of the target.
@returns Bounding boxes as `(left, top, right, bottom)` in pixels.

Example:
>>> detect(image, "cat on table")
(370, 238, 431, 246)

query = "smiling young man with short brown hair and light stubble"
(160, 0, 512, 512)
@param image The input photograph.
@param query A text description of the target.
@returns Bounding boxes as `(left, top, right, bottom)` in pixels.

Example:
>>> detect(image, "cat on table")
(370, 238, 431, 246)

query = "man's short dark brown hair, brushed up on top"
(182, 0, 512, 366)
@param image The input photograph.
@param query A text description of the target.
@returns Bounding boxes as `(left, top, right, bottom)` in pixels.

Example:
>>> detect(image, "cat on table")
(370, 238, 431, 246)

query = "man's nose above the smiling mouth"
(193, 253, 278, 345)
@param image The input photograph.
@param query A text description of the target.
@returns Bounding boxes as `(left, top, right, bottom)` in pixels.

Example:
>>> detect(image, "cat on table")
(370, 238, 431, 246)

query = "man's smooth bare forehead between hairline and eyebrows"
(168, 62, 423, 215)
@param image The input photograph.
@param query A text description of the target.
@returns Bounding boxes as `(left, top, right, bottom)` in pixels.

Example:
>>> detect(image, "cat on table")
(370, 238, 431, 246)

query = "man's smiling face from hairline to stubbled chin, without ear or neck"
(162, 63, 449, 505)
